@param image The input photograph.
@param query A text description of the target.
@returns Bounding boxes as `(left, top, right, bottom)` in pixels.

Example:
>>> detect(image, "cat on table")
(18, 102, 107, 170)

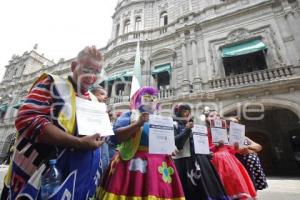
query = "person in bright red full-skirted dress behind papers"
(206, 111, 256, 200)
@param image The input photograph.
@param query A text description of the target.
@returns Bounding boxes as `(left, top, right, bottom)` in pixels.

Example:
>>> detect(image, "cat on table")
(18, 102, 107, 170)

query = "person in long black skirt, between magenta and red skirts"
(174, 104, 229, 200)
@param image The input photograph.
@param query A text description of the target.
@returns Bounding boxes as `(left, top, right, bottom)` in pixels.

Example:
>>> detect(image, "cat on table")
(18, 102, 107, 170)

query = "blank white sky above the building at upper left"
(0, 0, 118, 81)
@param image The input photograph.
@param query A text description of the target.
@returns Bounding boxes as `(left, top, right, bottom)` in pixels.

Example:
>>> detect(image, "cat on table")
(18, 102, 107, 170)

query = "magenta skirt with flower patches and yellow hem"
(97, 150, 185, 200)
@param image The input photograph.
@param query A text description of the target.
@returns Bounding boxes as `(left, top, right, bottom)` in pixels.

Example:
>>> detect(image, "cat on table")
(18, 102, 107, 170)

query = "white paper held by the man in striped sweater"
(76, 97, 114, 136)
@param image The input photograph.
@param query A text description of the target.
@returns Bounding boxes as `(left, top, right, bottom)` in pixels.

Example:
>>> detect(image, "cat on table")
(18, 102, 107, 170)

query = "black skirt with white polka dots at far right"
(236, 153, 268, 190)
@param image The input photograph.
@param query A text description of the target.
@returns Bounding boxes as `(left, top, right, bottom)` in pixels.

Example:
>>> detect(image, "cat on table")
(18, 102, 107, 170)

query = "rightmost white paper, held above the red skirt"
(229, 122, 245, 147)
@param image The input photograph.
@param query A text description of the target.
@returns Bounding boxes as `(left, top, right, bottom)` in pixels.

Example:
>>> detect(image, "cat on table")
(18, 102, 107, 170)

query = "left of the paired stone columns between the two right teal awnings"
(181, 41, 190, 93)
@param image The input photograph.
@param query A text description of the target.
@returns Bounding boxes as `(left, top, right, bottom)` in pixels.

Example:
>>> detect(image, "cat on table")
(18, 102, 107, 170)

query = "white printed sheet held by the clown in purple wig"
(149, 115, 175, 155)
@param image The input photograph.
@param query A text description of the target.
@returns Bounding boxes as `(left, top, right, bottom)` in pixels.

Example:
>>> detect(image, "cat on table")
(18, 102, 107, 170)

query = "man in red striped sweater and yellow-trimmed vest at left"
(4, 46, 104, 200)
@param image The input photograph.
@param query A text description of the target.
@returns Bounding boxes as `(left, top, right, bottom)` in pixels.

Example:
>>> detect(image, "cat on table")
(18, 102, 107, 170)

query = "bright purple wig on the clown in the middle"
(130, 86, 158, 109)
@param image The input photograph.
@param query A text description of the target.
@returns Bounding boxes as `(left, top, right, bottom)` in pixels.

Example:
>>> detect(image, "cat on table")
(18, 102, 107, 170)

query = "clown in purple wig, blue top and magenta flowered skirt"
(98, 86, 185, 200)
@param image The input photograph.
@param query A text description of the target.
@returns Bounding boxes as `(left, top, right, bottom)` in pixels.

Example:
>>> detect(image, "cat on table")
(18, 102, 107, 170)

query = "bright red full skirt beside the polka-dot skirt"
(212, 148, 256, 199)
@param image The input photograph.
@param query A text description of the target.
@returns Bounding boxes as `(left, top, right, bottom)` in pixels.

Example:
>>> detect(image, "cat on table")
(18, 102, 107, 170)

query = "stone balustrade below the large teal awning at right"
(209, 66, 293, 89)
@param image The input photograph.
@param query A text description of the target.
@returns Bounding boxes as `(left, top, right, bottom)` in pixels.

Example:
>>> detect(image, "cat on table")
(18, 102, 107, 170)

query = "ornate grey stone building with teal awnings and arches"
(0, 0, 300, 174)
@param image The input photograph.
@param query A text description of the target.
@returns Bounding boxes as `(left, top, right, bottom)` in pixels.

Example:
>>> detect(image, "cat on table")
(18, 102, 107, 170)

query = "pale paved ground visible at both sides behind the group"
(0, 165, 300, 200)
